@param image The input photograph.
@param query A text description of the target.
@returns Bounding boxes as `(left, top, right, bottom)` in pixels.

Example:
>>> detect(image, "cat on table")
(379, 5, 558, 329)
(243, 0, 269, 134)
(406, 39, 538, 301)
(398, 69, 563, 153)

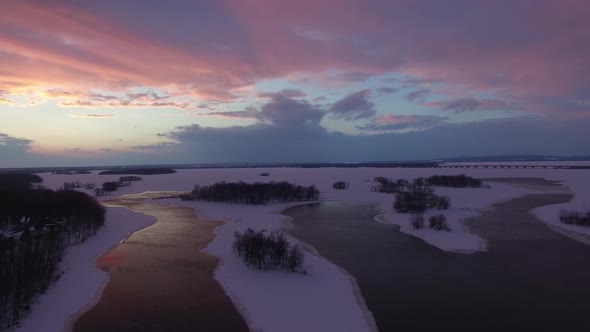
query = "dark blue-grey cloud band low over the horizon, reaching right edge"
(159, 116, 590, 162)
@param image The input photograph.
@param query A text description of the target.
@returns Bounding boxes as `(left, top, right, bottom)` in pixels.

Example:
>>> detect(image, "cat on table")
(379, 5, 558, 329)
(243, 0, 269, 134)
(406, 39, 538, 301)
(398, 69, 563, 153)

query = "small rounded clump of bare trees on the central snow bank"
(233, 228, 304, 272)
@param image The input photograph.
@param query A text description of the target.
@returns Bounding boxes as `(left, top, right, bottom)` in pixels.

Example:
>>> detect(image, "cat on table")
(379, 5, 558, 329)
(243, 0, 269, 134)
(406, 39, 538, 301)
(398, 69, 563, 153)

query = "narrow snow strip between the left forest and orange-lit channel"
(15, 207, 155, 332)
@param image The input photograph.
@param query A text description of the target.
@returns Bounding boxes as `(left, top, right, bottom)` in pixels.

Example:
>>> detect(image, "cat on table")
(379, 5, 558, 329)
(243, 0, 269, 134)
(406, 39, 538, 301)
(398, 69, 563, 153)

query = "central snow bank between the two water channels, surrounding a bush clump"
(153, 199, 376, 332)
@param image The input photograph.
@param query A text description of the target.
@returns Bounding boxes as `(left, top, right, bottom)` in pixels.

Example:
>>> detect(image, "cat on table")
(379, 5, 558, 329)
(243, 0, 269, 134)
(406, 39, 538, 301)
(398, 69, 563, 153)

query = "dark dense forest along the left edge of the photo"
(0, 174, 105, 329)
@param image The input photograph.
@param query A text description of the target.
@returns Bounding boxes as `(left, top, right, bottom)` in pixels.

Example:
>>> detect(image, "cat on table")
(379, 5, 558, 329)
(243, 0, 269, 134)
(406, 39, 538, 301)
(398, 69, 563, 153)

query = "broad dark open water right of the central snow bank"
(285, 194, 590, 332)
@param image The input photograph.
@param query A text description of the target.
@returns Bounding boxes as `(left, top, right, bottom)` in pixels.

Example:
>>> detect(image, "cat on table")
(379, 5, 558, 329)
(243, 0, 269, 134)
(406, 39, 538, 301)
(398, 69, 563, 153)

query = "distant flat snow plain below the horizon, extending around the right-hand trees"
(37, 168, 590, 252)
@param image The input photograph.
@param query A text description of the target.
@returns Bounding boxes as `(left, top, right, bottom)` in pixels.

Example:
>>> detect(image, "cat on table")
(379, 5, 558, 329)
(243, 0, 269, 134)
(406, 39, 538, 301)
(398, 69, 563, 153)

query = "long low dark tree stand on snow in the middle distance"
(181, 181, 320, 205)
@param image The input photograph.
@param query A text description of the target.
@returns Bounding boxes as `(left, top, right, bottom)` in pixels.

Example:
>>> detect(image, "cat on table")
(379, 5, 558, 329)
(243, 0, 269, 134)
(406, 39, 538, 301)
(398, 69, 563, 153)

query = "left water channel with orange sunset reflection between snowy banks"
(73, 196, 248, 332)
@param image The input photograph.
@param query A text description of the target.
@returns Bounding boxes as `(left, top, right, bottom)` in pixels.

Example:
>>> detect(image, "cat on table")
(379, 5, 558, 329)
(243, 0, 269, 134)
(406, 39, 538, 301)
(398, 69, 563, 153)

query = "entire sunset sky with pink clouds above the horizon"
(0, 0, 590, 168)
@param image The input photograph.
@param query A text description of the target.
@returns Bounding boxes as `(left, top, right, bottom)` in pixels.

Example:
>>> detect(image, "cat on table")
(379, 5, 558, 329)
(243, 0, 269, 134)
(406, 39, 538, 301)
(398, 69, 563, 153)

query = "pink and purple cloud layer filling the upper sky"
(0, 0, 590, 116)
